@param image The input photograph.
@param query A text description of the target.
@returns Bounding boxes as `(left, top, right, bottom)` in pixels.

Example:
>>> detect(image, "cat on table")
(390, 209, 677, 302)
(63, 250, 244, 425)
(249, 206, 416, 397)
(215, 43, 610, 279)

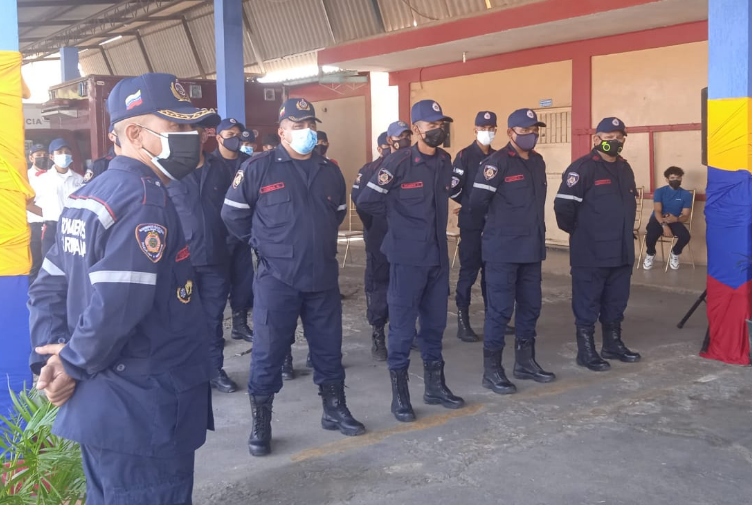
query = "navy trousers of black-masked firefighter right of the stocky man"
(387, 263, 449, 370)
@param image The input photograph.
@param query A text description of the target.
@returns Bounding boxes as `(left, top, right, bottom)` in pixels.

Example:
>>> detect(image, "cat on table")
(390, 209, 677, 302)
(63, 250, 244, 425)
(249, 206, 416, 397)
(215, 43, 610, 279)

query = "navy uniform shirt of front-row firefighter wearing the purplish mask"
(470, 143, 547, 263)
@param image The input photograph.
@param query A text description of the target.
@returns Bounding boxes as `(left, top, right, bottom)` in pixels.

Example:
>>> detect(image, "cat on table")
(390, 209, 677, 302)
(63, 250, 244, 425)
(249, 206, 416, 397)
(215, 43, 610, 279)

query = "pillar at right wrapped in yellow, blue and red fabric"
(701, 0, 752, 365)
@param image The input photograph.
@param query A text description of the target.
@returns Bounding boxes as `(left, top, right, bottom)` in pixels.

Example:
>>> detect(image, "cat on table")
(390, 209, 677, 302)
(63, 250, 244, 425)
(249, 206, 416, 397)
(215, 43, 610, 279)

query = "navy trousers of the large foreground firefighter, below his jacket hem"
(81, 445, 194, 505)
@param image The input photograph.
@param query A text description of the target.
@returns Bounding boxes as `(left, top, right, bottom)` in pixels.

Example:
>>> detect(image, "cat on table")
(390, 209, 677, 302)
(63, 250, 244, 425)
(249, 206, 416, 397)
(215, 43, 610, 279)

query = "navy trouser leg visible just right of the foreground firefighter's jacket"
(193, 265, 230, 377)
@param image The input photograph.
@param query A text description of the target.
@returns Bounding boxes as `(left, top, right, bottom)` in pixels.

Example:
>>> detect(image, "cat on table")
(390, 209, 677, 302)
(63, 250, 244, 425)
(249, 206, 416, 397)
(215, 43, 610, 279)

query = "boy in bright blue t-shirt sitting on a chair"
(642, 167, 692, 270)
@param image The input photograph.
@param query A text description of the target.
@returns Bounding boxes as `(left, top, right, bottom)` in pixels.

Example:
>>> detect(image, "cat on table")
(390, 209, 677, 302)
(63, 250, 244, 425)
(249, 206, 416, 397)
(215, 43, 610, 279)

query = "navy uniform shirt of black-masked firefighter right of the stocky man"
(357, 144, 462, 266)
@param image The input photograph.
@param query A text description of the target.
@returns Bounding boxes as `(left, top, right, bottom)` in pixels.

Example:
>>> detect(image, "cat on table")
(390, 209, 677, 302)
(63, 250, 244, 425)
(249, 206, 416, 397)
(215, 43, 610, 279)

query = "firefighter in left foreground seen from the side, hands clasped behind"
(29, 74, 213, 505)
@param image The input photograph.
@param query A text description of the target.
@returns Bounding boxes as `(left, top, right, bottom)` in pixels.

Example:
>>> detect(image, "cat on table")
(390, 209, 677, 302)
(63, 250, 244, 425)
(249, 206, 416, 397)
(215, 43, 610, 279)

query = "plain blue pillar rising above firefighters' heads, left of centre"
(214, 0, 245, 124)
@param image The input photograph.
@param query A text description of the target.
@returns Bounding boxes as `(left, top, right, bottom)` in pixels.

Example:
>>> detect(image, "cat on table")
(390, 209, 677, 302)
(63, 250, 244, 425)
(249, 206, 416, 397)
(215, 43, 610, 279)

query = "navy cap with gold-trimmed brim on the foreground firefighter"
(107, 73, 218, 124)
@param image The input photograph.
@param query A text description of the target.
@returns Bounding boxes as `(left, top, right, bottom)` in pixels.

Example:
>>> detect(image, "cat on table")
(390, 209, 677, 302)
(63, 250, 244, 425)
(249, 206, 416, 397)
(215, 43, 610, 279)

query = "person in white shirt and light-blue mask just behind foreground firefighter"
(36, 139, 84, 256)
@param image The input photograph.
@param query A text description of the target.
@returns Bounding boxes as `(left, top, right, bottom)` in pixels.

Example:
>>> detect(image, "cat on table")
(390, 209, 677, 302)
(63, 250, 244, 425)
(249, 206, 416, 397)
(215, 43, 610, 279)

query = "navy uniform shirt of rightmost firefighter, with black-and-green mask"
(554, 149, 637, 267)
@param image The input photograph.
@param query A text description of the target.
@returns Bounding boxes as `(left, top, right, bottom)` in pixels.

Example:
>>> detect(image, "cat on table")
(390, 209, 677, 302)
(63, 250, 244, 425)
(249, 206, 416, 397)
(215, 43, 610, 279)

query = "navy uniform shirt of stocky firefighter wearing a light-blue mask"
(222, 145, 347, 292)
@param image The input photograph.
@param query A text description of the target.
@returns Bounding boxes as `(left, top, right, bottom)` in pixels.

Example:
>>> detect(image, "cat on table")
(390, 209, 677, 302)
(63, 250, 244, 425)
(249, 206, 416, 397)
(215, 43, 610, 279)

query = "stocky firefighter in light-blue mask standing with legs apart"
(222, 98, 365, 456)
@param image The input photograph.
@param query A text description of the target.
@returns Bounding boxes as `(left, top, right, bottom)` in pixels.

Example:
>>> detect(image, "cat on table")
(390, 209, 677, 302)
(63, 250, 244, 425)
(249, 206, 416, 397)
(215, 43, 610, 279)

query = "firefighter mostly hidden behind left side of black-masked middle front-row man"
(350, 132, 392, 361)
